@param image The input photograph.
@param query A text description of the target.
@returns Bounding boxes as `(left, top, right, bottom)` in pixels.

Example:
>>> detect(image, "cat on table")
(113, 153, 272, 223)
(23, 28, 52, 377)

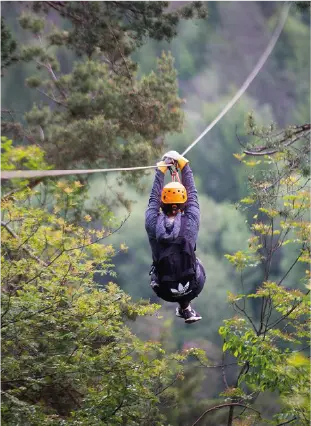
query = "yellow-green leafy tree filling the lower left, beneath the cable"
(0, 138, 187, 426)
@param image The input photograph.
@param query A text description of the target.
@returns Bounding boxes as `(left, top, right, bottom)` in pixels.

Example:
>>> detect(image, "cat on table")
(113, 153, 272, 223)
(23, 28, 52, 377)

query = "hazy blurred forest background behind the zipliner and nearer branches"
(0, 0, 311, 426)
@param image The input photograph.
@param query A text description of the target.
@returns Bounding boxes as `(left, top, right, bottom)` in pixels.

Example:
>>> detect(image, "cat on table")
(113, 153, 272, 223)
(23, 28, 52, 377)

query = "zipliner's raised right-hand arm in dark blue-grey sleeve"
(181, 164, 200, 227)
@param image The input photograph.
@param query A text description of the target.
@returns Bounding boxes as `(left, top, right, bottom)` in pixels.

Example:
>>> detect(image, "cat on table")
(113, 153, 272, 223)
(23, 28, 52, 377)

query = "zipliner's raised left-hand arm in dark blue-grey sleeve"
(145, 169, 164, 236)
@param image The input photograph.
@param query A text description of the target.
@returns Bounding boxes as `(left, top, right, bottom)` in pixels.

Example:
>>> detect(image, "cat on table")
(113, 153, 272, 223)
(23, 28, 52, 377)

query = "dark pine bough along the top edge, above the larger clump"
(32, 0, 206, 56)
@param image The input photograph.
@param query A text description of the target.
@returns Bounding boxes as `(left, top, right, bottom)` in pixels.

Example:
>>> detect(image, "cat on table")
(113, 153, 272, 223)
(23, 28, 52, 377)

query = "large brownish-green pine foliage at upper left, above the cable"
(0, 0, 205, 168)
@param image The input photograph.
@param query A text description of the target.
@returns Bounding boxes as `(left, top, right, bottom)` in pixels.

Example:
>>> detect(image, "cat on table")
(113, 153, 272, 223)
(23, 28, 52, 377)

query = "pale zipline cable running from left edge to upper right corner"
(0, 2, 291, 179)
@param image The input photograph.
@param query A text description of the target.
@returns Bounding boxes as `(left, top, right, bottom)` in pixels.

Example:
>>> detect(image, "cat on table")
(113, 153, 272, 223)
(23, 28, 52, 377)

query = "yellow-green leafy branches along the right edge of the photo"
(219, 120, 311, 425)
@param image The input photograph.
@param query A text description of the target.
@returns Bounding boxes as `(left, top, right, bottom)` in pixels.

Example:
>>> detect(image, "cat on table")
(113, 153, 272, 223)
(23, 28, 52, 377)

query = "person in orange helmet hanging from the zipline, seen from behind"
(145, 151, 206, 324)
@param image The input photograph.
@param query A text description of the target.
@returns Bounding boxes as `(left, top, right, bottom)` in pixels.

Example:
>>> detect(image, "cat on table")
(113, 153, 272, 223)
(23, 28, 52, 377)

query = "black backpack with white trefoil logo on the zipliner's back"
(153, 216, 197, 299)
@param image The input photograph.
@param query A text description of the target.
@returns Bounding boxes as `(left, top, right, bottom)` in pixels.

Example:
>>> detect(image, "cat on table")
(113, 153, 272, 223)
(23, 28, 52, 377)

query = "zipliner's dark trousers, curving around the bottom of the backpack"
(150, 258, 206, 307)
